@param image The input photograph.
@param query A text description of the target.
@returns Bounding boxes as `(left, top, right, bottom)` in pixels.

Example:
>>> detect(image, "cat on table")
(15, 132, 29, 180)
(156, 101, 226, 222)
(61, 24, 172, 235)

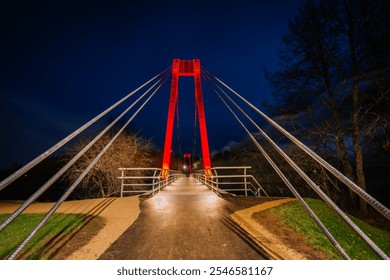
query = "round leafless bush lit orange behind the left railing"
(66, 133, 152, 198)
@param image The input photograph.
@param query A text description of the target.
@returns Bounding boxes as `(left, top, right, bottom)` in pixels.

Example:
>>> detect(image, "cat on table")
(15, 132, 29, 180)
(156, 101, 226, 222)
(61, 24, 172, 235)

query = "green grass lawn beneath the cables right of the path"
(267, 199, 390, 260)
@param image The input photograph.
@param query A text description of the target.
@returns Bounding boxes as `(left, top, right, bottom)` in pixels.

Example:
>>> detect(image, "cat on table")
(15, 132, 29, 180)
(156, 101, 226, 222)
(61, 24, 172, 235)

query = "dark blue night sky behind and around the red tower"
(0, 0, 301, 168)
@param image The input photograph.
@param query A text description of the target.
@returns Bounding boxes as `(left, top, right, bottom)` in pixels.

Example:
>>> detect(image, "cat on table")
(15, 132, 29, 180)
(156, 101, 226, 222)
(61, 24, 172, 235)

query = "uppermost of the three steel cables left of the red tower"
(0, 67, 171, 191)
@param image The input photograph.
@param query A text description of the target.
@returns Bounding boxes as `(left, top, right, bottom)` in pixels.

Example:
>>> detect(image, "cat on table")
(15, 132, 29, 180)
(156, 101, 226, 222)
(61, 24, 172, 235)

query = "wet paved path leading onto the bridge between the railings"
(100, 177, 267, 260)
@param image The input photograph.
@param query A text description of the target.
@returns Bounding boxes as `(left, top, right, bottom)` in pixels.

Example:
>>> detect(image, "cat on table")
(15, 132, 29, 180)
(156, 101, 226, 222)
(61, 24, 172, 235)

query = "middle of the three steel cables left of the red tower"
(0, 71, 168, 232)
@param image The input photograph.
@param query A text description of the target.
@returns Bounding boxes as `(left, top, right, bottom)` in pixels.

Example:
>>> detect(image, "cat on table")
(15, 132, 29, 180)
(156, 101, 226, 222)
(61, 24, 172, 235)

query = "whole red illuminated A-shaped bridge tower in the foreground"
(162, 59, 211, 177)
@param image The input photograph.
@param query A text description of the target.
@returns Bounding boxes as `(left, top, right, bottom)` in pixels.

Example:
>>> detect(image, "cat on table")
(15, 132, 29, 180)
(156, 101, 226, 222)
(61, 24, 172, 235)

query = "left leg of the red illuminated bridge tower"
(162, 59, 180, 178)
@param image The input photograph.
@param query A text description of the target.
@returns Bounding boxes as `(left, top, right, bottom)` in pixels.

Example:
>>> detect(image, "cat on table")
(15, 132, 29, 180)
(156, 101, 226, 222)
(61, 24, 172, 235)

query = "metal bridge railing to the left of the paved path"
(118, 167, 183, 197)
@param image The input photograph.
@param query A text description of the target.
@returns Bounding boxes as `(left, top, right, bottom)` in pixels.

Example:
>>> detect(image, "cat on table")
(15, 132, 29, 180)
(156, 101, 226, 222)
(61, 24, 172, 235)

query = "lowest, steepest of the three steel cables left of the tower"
(8, 72, 166, 260)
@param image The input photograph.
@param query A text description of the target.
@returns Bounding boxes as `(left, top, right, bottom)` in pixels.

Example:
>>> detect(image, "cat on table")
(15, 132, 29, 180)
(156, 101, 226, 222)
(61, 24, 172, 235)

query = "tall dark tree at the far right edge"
(338, 0, 390, 212)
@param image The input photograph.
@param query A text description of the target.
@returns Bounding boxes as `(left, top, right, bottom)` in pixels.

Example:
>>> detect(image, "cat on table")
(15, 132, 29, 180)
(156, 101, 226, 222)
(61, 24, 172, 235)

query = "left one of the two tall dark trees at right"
(268, 1, 354, 179)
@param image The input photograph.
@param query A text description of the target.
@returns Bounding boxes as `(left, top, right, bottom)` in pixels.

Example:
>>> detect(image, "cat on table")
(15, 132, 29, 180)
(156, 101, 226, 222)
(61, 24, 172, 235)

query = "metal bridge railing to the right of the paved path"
(194, 166, 268, 196)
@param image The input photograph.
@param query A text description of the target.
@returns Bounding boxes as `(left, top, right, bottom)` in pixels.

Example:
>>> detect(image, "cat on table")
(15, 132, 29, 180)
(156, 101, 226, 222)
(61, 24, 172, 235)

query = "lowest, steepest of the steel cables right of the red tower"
(207, 80, 351, 260)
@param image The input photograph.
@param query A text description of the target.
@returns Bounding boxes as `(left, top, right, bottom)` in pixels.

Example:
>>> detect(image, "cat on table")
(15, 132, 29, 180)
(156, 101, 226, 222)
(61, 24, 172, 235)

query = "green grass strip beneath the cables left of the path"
(0, 214, 86, 259)
